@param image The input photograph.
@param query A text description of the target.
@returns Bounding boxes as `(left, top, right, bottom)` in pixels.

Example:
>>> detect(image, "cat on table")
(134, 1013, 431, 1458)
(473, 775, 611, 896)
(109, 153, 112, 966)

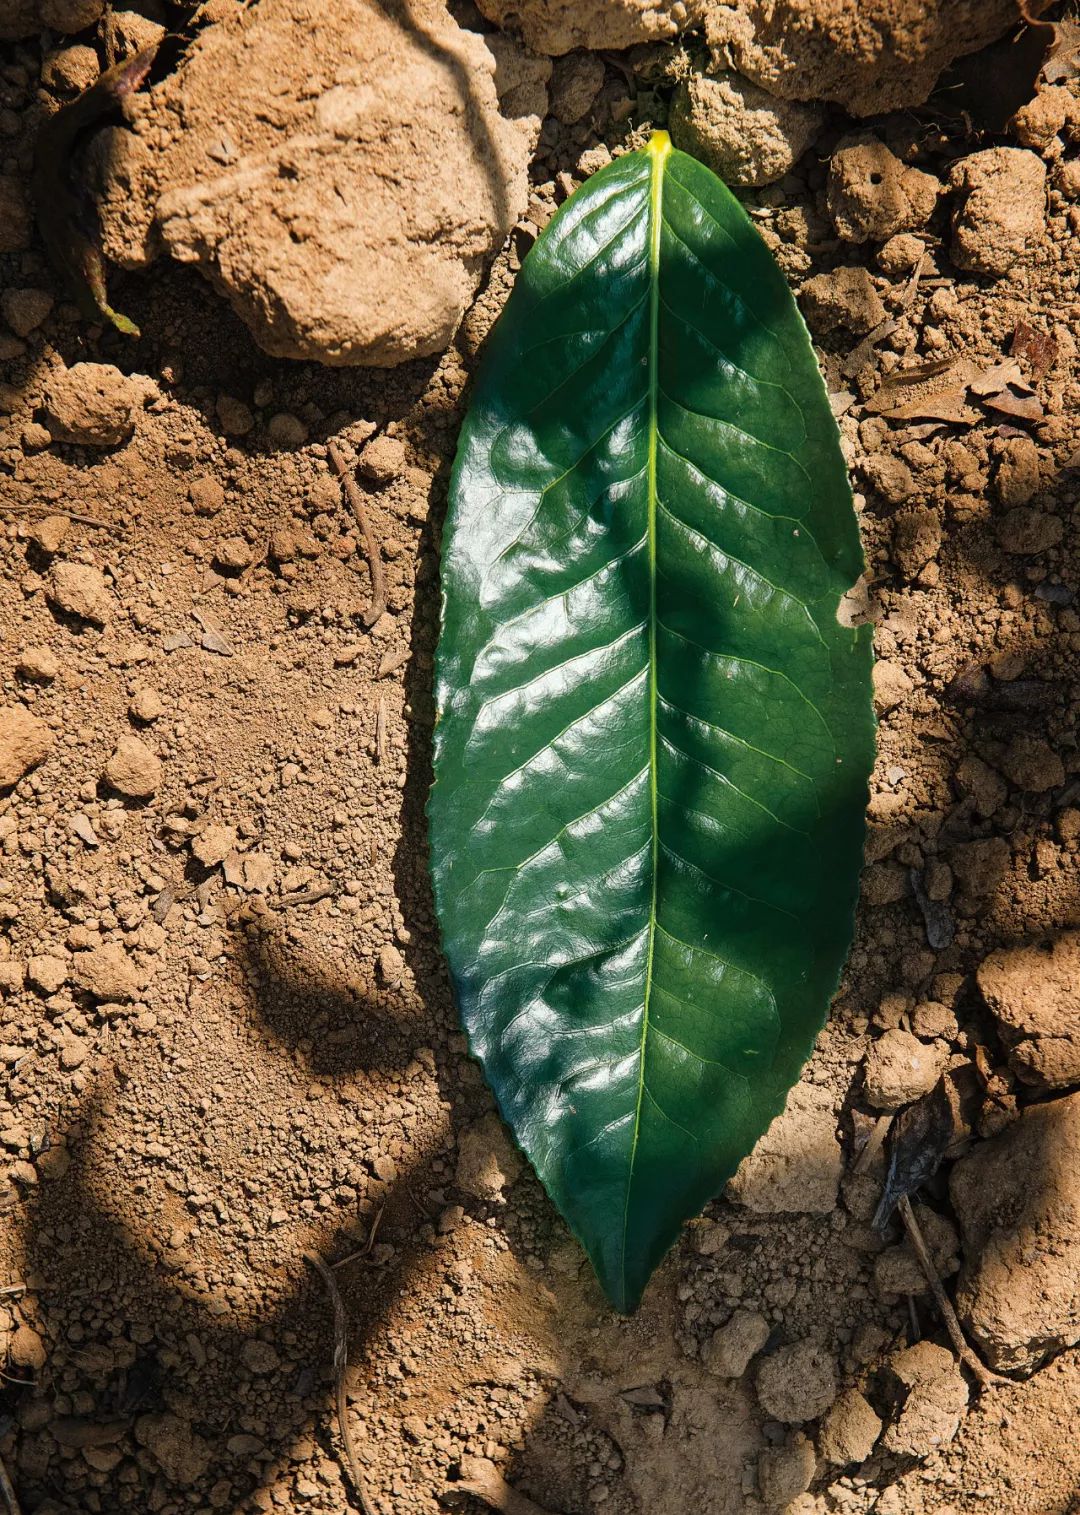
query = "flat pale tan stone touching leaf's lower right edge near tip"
(727, 1083, 842, 1215)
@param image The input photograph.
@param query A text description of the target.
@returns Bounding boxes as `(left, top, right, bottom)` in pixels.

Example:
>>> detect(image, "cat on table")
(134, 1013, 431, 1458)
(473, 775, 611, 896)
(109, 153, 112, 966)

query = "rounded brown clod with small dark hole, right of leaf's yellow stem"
(826, 138, 941, 242)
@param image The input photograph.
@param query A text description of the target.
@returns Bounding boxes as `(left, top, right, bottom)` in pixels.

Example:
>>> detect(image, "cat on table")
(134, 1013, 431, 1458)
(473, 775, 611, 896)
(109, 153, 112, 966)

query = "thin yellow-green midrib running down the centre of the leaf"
(620, 132, 671, 1298)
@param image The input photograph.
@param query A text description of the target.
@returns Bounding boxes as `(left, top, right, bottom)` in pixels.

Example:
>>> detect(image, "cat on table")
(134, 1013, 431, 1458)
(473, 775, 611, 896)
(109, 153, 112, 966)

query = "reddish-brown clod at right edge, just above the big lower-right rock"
(975, 932, 1080, 1092)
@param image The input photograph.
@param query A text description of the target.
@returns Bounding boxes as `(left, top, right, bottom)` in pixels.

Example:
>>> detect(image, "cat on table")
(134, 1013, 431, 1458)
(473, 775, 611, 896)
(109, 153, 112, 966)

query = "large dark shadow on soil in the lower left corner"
(0, 1085, 451, 1509)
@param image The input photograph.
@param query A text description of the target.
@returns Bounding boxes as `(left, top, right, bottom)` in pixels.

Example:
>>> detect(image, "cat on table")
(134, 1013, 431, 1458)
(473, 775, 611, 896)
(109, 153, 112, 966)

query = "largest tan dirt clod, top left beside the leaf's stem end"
(97, 0, 550, 365)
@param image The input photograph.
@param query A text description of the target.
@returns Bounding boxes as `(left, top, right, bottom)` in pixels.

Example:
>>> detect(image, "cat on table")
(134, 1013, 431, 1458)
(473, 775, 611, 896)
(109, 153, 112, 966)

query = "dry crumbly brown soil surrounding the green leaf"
(0, 6, 1080, 1515)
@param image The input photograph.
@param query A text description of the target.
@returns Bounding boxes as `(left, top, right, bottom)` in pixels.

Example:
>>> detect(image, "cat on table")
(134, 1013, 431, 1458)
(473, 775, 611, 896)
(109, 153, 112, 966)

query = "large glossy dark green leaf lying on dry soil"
(429, 133, 874, 1310)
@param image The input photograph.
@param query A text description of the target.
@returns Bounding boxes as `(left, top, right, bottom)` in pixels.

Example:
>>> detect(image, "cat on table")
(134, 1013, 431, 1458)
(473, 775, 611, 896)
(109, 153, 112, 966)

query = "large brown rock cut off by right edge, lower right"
(948, 1094, 1080, 1373)
